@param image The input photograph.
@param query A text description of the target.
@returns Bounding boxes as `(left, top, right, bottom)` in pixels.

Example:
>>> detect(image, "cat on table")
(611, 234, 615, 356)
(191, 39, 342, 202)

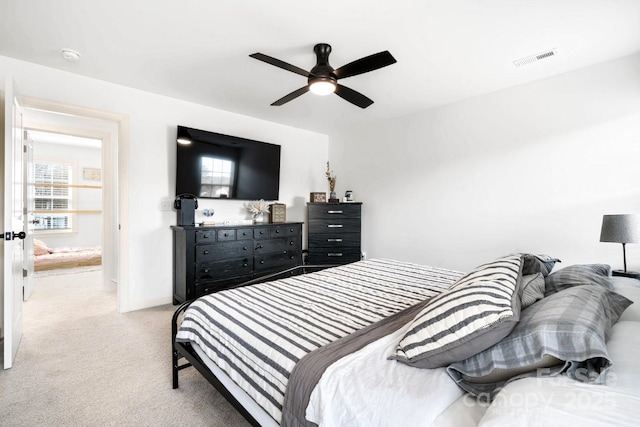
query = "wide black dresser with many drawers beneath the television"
(171, 222, 302, 304)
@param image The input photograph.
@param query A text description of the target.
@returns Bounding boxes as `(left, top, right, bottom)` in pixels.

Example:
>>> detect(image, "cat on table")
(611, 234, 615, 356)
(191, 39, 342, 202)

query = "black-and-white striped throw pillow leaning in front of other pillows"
(391, 254, 522, 368)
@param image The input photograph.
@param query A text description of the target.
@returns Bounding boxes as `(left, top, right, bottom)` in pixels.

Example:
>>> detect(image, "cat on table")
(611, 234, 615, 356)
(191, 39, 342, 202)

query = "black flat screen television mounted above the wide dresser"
(176, 126, 280, 200)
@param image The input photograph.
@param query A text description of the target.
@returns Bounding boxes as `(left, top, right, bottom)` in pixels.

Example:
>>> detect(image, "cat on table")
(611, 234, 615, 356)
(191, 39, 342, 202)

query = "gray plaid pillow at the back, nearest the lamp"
(544, 264, 613, 296)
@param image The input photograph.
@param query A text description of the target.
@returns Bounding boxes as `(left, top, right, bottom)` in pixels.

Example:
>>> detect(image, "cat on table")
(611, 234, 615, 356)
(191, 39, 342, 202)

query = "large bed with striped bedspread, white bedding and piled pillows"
(172, 254, 640, 427)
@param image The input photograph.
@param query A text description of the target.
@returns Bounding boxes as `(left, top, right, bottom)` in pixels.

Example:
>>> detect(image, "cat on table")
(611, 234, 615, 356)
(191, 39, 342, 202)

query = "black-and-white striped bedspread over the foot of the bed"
(176, 260, 462, 423)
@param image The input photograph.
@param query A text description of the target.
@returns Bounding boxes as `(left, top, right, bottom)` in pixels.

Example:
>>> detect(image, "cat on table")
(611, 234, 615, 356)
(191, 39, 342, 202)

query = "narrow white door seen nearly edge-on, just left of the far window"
(22, 131, 36, 301)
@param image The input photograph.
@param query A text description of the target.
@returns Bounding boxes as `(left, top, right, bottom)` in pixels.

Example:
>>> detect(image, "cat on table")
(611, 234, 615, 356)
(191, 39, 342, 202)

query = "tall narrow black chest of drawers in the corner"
(307, 203, 362, 264)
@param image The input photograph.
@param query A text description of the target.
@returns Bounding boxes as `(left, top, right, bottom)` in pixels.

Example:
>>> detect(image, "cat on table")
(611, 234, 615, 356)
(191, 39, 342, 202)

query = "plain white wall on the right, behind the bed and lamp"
(330, 55, 640, 270)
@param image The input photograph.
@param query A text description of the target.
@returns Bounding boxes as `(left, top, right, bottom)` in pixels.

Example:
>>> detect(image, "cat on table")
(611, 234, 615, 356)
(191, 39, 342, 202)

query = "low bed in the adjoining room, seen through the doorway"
(33, 239, 102, 271)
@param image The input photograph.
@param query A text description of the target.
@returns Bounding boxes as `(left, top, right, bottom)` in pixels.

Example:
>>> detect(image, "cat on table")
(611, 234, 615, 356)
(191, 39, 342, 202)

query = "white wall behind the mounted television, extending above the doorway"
(0, 57, 328, 311)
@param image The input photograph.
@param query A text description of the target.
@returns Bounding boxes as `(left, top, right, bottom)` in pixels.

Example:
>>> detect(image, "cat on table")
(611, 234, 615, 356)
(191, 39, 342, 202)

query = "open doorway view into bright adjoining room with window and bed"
(25, 129, 103, 278)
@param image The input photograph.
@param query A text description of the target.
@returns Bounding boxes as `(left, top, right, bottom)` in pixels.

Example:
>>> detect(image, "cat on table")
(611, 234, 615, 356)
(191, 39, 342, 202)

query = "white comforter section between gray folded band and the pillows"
(306, 325, 464, 427)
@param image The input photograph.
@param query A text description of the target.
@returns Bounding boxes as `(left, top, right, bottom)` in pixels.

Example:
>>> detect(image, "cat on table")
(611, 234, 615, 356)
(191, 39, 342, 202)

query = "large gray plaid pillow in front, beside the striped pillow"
(447, 286, 632, 401)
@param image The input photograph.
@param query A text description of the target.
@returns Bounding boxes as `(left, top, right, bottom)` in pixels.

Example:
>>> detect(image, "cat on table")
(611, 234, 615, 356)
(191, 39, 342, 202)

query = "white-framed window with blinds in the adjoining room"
(34, 161, 72, 231)
